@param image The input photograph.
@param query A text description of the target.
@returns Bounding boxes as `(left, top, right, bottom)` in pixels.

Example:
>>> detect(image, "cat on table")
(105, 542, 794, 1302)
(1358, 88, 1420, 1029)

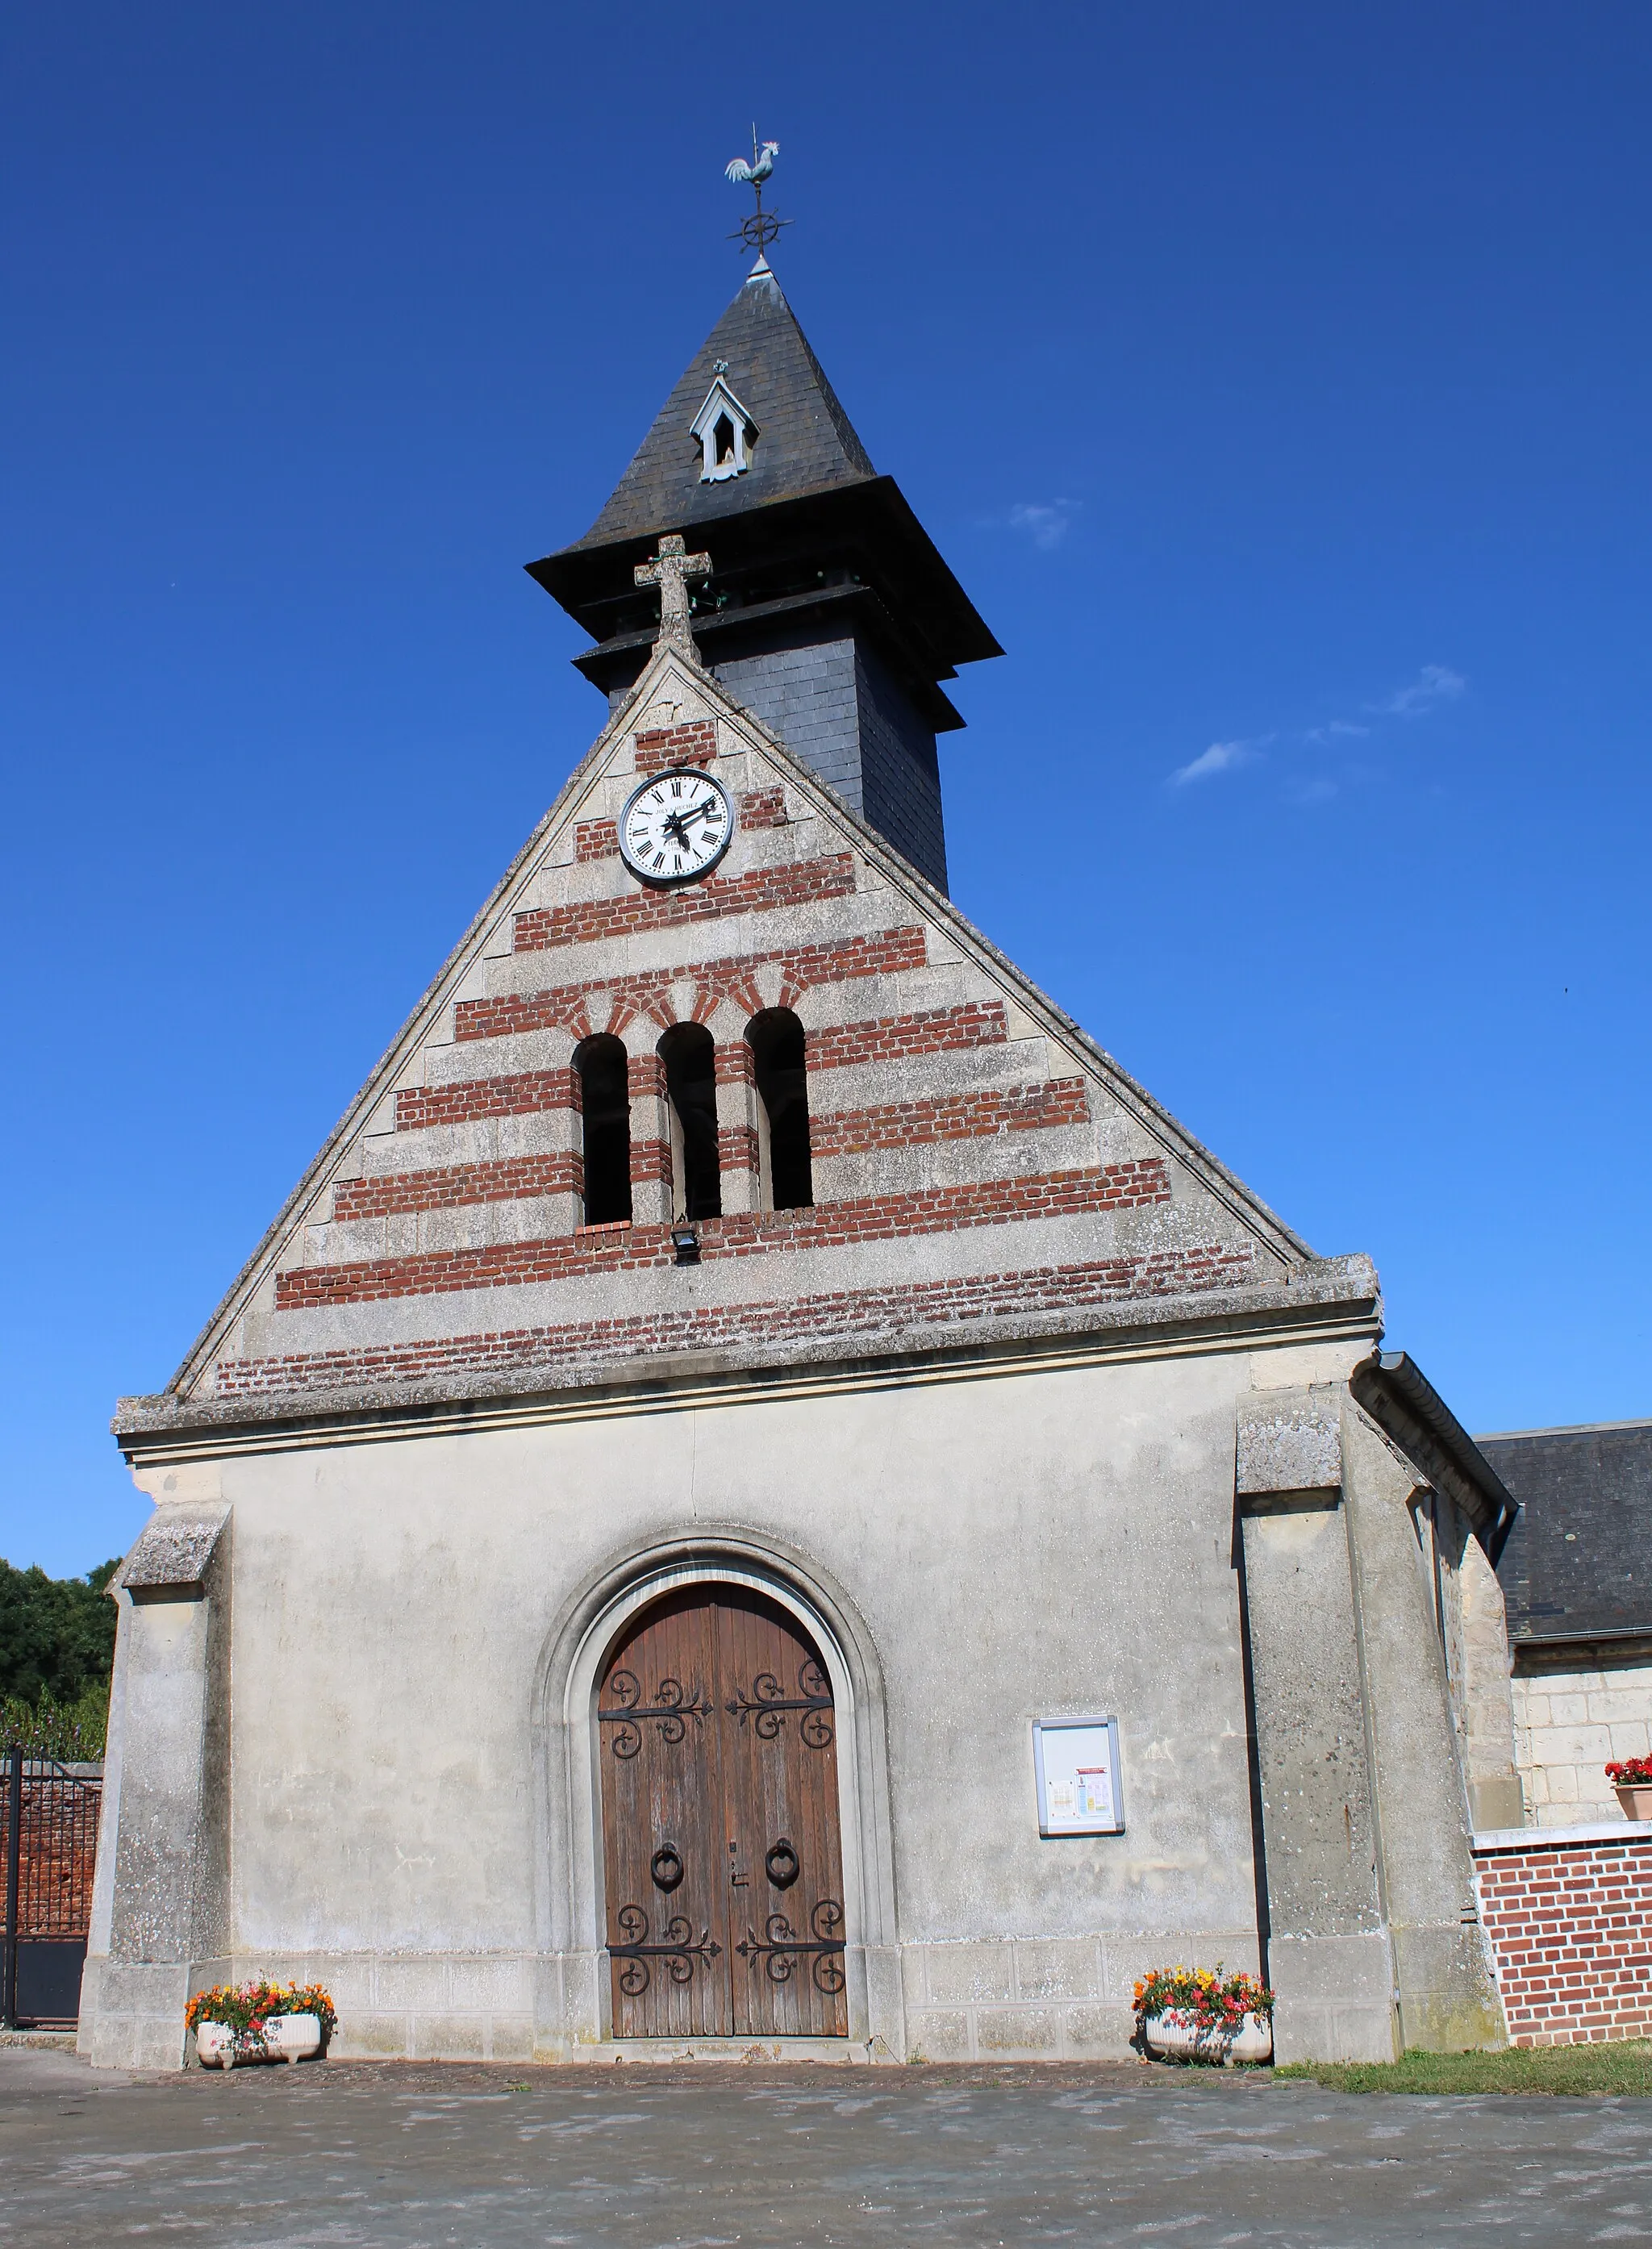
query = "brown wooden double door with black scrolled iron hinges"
(598, 1586, 849, 2038)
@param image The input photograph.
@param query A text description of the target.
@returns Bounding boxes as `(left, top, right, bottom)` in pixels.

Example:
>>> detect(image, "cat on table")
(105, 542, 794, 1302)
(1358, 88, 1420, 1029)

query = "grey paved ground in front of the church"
(0, 2049, 1652, 2249)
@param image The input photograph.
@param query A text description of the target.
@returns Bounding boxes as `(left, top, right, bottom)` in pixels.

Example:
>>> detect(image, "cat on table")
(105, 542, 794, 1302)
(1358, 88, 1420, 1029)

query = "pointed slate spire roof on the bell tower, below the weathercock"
(562, 259, 877, 553)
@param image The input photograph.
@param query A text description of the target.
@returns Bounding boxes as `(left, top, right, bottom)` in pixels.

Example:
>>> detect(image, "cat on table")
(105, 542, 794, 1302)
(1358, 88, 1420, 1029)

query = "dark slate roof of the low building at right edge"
(1475, 1421, 1652, 1642)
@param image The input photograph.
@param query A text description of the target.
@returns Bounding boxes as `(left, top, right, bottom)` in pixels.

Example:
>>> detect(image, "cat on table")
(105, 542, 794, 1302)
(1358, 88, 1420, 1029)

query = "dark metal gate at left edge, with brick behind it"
(0, 1750, 103, 2031)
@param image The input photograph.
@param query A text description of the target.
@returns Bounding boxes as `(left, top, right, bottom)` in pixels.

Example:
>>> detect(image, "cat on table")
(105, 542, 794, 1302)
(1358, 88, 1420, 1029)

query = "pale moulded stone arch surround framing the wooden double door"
(535, 1527, 906, 2063)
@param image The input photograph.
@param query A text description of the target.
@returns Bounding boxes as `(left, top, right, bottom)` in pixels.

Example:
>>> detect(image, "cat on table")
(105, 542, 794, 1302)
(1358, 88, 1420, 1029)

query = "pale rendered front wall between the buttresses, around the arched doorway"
(96, 1347, 1384, 2055)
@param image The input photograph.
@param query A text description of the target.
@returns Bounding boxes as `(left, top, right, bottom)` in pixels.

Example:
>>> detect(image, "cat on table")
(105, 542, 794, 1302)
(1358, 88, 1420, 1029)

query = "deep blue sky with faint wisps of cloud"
(0, 0, 1652, 1572)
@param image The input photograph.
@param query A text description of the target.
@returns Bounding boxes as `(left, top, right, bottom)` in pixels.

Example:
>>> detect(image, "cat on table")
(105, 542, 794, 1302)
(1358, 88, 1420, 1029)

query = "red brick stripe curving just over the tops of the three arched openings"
(454, 928, 930, 1059)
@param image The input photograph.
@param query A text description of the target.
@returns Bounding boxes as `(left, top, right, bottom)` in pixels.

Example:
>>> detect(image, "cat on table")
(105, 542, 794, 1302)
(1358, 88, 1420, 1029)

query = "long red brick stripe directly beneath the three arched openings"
(277, 1169, 1171, 1311)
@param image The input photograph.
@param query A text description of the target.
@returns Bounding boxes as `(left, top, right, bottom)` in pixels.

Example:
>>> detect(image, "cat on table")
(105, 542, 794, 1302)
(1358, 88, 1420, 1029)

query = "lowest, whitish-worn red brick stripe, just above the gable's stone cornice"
(218, 1219, 1252, 1396)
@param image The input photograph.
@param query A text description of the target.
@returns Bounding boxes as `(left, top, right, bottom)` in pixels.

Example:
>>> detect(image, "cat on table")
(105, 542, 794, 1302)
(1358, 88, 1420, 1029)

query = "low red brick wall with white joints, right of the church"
(1475, 1829, 1652, 2047)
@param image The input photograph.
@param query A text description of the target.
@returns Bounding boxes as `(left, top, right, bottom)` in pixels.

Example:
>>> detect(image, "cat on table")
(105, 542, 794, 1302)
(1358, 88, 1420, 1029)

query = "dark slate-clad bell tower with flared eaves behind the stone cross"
(528, 254, 1003, 891)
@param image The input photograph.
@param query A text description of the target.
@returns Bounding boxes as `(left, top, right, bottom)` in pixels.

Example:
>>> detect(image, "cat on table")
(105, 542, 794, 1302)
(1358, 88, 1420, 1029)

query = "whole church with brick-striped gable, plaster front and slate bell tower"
(81, 261, 1520, 2064)
